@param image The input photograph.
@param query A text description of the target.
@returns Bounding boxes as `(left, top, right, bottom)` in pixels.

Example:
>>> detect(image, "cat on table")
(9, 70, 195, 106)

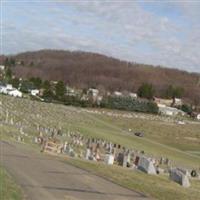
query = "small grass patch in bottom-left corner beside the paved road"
(0, 166, 23, 200)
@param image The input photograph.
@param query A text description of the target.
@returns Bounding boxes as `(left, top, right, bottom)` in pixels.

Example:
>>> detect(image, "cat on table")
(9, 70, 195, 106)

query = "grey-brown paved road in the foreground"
(0, 141, 147, 200)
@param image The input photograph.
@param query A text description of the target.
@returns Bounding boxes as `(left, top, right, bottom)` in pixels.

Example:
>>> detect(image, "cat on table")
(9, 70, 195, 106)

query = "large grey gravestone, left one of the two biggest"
(138, 156, 156, 174)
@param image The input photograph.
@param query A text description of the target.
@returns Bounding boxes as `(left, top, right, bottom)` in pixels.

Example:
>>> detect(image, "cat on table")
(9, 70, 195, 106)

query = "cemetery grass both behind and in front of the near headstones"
(0, 96, 200, 200)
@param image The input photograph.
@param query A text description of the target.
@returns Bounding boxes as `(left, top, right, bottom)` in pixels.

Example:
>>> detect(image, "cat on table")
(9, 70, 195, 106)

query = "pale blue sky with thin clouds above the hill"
(1, 0, 200, 72)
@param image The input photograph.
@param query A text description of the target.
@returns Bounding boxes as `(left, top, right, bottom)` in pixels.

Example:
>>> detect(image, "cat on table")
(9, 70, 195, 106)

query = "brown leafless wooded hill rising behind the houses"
(1, 50, 200, 103)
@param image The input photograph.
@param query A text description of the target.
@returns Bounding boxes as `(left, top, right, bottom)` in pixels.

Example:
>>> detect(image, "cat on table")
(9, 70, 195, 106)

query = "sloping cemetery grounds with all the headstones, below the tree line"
(0, 96, 200, 200)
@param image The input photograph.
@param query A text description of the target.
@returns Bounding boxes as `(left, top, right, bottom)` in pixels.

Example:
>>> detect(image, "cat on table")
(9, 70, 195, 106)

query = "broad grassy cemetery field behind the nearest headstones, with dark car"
(1, 96, 200, 168)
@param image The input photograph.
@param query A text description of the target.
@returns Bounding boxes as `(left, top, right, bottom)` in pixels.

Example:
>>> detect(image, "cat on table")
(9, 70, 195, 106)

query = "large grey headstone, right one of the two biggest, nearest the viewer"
(169, 168, 190, 187)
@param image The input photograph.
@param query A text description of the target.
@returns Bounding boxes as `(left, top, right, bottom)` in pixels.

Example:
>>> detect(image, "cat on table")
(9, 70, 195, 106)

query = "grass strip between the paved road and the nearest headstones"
(65, 159, 200, 200)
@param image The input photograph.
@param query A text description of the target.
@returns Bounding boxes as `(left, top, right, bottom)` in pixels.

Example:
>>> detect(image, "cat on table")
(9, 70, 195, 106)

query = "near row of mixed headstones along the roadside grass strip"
(34, 127, 198, 187)
